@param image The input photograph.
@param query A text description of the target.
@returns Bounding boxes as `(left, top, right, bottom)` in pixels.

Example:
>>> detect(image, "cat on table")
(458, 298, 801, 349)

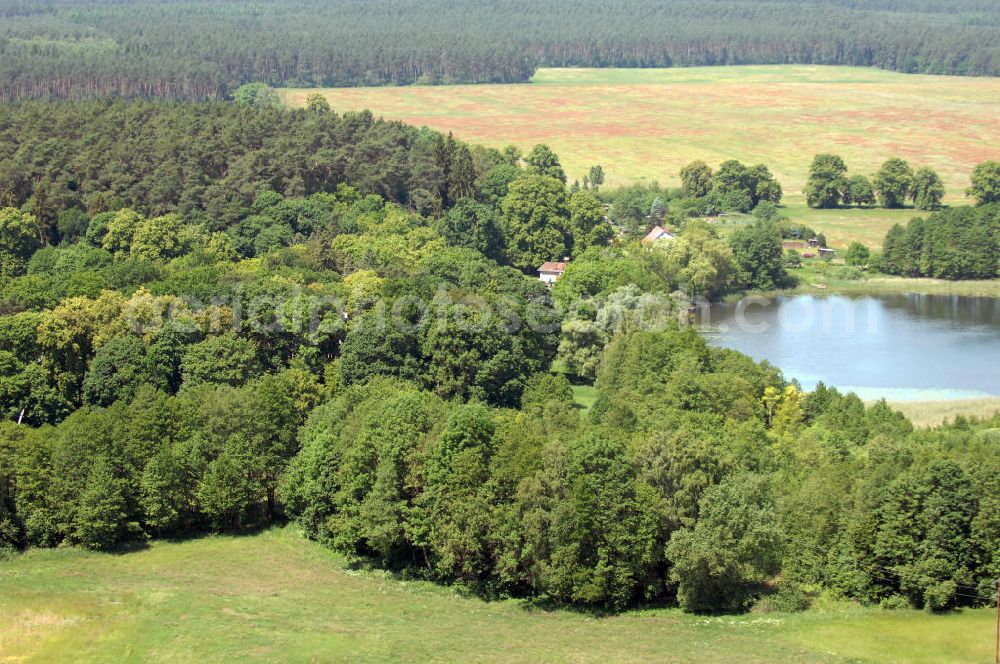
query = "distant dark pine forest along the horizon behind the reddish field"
(0, 0, 1000, 100)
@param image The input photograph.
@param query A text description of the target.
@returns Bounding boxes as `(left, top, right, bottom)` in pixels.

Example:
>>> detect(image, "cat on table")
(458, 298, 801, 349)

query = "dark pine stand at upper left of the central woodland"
(0, 100, 492, 242)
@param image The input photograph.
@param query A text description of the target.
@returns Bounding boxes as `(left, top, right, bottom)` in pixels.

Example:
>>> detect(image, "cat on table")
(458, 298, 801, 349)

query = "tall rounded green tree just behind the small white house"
(500, 175, 569, 270)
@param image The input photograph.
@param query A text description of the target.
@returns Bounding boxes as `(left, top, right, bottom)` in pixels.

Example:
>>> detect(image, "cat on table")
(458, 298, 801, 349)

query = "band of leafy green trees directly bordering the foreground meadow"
(0, 326, 1000, 611)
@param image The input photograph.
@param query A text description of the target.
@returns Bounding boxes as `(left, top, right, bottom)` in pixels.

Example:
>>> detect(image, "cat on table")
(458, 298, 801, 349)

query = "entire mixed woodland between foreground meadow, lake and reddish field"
(0, 100, 1000, 611)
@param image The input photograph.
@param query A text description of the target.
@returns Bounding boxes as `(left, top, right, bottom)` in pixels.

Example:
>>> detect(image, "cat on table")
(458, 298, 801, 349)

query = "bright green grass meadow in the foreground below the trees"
(0, 527, 993, 663)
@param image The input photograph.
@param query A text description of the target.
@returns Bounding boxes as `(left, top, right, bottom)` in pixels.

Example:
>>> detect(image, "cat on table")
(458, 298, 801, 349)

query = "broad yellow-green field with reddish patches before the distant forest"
(281, 65, 1000, 247)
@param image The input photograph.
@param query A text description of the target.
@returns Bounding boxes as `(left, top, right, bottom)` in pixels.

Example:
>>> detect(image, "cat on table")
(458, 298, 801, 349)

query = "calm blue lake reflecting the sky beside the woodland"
(700, 295, 1000, 401)
